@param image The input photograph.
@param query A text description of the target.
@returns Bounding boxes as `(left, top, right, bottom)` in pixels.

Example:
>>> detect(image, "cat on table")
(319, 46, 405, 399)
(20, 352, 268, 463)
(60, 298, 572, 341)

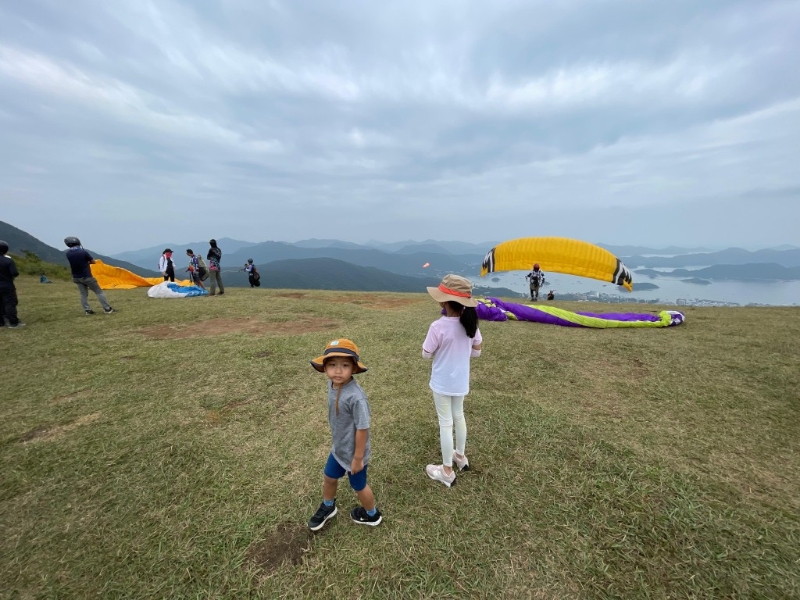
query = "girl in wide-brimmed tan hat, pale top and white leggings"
(422, 275, 483, 487)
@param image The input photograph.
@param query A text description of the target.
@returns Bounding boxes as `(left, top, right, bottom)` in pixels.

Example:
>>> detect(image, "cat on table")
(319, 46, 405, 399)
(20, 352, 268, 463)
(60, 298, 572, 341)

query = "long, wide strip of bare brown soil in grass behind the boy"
(139, 317, 338, 340)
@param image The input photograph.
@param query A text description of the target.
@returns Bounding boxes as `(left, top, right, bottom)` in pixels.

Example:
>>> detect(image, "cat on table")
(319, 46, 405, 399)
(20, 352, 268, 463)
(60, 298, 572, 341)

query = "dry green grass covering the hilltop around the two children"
(0, 279, 800, 598)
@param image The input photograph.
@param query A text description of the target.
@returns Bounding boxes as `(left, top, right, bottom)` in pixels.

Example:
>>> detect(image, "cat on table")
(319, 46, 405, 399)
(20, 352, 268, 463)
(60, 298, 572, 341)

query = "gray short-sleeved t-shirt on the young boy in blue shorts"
(328, 379, 370, 472)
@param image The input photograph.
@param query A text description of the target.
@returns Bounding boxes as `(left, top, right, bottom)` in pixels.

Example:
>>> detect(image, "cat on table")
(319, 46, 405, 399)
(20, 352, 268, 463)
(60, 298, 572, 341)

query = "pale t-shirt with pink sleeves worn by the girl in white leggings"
(422, 317, 483, 396)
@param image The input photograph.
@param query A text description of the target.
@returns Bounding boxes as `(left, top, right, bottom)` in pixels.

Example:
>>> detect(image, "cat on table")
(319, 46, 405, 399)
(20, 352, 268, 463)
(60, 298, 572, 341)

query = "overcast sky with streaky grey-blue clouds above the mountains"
(0, 0, 800, 254)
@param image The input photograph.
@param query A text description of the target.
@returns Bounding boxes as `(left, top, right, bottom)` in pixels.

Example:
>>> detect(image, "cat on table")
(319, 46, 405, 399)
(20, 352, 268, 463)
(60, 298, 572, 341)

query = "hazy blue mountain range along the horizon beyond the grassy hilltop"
(6, 221, 800, 294)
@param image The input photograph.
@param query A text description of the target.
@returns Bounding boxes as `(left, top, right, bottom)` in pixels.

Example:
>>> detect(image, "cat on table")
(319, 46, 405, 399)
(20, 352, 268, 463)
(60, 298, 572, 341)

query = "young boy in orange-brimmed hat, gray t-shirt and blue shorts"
(308, 339, 382, 531)
